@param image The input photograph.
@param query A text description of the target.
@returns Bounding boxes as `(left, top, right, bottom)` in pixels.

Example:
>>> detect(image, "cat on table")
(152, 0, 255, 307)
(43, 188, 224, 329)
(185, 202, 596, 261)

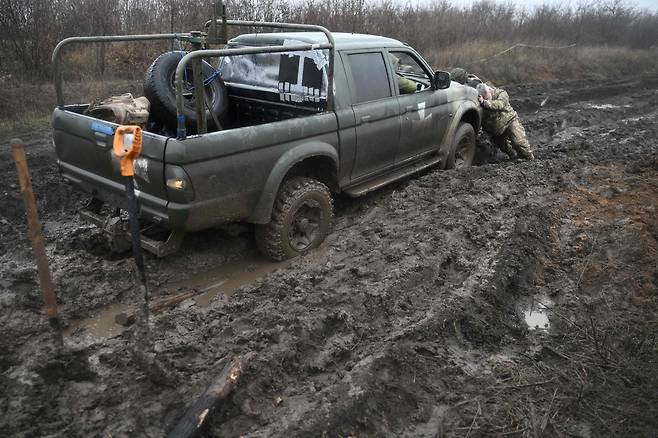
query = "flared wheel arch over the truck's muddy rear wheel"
(247, 142, 339, 224)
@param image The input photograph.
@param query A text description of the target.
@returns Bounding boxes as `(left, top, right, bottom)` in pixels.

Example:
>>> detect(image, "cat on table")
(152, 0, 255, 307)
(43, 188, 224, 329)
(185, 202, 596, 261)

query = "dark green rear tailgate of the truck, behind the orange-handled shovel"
(53, 107, 167, 221)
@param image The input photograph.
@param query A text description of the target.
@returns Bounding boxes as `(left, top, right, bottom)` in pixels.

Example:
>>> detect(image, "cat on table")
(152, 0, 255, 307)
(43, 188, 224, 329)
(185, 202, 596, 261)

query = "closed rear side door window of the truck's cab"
(347, 53, 391, 103)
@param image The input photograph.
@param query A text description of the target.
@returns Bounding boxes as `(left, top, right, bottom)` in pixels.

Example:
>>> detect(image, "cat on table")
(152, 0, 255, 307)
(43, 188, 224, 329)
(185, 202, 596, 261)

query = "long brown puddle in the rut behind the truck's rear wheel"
(64, 254, 292, 342)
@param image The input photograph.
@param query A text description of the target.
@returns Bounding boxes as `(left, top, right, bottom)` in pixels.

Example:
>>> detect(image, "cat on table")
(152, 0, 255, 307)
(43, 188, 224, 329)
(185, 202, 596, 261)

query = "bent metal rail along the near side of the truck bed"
(174, 43, 332, 139)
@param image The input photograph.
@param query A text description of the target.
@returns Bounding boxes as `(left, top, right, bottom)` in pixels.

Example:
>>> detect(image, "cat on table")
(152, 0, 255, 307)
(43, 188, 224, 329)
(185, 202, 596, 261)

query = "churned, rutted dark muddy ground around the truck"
(0, 77, 658, 437)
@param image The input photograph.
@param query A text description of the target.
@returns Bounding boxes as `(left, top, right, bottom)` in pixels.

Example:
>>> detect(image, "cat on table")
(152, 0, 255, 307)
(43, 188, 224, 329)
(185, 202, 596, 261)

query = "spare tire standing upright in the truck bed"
(144, 52, 228, 132)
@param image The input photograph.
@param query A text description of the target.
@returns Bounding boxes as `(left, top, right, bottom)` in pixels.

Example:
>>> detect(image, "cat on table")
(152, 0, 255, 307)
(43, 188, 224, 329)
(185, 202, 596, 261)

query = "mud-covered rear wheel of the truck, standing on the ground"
(256, 177, 334, 260)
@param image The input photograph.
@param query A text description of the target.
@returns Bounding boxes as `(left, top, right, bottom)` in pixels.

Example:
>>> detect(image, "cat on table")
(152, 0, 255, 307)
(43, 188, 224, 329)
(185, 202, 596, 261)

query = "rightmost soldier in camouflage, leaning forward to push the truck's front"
(476, 83, 535, 160)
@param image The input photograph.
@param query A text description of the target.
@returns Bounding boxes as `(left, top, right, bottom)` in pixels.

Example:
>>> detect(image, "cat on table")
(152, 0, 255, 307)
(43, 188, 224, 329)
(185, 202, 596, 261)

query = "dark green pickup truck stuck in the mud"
(53, 21, 481, 260)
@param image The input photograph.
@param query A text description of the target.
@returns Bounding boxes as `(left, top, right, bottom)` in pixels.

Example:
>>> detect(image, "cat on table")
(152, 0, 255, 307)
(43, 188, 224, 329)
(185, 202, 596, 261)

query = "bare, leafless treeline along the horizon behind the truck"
(0, 0, 658, 78)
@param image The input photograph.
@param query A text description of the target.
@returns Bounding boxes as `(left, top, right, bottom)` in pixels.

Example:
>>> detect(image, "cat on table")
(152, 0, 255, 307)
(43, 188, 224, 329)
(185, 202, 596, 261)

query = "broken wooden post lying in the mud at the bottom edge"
(167, 357, 242, 438)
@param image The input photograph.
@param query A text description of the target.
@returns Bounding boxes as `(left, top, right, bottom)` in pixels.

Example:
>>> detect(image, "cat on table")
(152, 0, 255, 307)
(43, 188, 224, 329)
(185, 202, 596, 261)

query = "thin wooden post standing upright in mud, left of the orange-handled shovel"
(10, 138, 64, 346)
